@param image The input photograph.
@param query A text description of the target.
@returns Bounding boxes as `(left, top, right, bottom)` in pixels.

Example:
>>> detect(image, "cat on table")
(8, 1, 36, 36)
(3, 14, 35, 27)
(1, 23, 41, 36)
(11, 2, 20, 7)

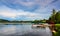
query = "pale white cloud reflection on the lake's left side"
(0, 26, 16, 34)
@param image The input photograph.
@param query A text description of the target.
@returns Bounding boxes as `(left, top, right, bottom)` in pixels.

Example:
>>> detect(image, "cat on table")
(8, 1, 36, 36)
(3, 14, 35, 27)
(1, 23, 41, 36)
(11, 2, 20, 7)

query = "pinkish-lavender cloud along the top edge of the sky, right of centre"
(13, 0, 54, 7)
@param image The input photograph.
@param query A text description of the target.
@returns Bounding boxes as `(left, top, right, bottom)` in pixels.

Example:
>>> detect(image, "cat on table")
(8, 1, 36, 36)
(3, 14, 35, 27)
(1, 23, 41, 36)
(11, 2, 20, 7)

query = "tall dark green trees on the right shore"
(49, 9, 60, 23)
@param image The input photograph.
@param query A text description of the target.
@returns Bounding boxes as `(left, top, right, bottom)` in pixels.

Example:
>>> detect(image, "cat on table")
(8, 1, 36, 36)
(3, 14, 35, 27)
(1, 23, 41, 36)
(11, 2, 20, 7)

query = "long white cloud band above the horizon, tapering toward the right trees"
(0, 6, 50, 20)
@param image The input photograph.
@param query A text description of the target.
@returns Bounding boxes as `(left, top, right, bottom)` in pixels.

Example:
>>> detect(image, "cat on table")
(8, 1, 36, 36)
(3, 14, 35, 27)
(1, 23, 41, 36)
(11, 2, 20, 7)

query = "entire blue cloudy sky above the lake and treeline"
(0, 0, 60, 20)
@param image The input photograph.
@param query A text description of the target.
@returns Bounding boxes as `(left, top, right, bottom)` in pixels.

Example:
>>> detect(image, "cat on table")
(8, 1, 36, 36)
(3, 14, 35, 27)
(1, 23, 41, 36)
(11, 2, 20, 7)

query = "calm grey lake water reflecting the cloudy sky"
(0, 23, 52, 36)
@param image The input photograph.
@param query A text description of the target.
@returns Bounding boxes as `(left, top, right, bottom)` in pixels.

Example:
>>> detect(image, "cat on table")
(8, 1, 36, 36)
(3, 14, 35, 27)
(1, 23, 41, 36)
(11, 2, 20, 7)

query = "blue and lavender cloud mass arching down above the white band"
(0, 0, 54, 11)
